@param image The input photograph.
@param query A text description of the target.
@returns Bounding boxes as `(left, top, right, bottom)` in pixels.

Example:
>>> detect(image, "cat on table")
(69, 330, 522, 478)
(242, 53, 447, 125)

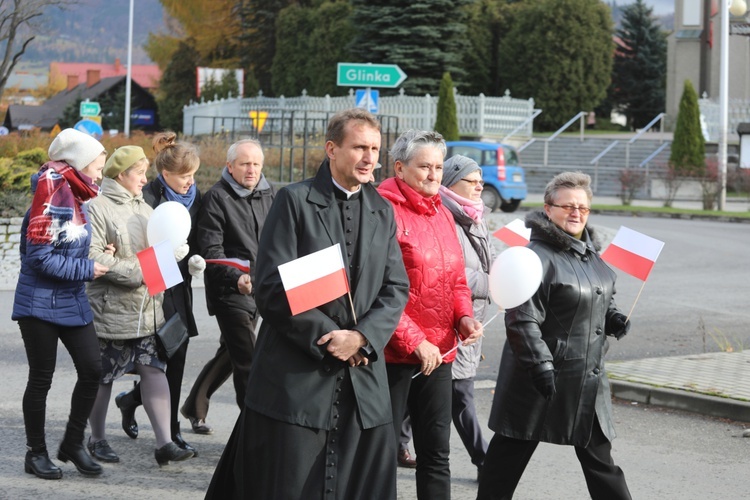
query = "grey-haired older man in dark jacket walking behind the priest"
(181, 139, 274, 434)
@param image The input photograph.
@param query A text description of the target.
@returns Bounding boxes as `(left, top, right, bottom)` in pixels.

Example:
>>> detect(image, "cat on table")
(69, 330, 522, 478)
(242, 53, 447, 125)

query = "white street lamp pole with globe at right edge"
(718, 0, 747, 211)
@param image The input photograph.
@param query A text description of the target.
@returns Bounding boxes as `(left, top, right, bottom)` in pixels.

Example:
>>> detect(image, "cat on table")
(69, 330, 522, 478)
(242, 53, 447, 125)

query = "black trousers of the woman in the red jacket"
(386, 363, 452, 500)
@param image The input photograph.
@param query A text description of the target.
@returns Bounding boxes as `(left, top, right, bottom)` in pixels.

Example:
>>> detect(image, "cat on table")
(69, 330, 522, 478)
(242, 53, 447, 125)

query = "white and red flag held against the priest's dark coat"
(279, 244, 349, 316)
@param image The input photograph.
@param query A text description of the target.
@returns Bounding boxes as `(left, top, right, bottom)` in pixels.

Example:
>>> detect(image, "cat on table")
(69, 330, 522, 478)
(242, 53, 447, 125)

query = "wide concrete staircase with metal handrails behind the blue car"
(519, 134, 671, 198)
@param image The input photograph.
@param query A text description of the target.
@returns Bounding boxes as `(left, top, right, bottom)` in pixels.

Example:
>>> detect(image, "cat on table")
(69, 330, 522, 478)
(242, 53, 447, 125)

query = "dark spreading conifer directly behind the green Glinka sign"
(351, 0, 471, 94)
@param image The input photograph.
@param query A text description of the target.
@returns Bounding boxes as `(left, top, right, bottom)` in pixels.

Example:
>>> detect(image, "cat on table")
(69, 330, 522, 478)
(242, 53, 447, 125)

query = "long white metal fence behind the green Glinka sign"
(183, 89, 534, 138)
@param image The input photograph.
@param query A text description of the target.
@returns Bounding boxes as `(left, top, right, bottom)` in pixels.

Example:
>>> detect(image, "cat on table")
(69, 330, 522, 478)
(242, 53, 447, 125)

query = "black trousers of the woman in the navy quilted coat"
(18, 318, 102, 450)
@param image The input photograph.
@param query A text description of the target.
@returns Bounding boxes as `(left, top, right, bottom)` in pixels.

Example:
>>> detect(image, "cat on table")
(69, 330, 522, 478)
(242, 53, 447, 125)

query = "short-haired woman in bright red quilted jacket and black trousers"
(378, 130, 482, 500)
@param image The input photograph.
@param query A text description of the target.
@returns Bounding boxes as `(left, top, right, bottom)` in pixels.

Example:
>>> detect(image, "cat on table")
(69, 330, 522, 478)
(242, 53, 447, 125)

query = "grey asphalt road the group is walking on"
(0, 212, 750, 500)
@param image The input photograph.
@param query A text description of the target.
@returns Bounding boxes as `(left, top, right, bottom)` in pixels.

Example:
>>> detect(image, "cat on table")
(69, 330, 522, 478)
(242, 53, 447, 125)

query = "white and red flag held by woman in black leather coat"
(602, 226, 664, 281)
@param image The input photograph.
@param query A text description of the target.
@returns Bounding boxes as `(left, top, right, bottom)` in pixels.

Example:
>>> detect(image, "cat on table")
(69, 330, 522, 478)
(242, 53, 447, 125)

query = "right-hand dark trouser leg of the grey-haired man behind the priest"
(216, 310, 256, 409)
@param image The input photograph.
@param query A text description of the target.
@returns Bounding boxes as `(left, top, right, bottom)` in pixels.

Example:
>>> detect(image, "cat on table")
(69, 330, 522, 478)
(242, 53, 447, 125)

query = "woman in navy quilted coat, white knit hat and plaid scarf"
(12, 129, 107, 479)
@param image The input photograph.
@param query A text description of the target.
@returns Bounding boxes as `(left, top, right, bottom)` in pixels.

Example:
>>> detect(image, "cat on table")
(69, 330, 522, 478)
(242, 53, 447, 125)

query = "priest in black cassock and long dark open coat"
(206, 109, 409, 500)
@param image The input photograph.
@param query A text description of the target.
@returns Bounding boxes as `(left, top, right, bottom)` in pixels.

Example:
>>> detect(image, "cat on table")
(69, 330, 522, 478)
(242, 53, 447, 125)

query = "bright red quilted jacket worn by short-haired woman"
(378, 178, 474, 364)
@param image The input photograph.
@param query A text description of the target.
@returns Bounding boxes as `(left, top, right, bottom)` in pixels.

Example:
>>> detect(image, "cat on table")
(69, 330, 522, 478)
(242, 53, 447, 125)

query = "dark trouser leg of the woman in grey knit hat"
(451, 378, 487, 467)
